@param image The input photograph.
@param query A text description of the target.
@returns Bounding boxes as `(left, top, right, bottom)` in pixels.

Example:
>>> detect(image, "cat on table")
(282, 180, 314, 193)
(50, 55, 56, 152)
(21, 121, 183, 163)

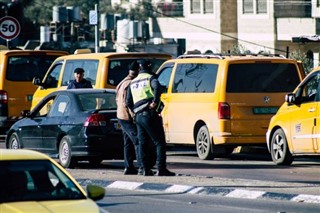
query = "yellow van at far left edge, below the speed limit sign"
(0, 50, 68, 136)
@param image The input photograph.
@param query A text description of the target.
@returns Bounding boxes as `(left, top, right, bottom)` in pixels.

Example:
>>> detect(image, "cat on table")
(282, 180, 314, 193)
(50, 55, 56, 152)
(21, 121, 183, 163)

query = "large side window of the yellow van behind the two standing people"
(172, 63, 218, 93)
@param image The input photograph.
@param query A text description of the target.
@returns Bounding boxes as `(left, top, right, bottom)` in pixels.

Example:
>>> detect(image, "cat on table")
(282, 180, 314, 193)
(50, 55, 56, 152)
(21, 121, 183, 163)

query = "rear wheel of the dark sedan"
(59, 136, 76, 168)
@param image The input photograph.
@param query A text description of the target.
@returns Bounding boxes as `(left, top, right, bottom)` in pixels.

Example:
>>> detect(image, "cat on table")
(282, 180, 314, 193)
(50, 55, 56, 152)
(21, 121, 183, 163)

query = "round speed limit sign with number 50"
(0, 16, 20, 40)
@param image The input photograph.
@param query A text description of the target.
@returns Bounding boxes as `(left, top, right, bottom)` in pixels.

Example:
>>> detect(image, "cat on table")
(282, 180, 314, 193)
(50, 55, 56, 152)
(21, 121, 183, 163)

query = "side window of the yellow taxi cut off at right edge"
(300, 73, 320, 103)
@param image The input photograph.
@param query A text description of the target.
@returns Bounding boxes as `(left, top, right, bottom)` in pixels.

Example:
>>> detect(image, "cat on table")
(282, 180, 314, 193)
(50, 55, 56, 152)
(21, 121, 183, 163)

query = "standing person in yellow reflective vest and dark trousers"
(126, 60, 175, 176)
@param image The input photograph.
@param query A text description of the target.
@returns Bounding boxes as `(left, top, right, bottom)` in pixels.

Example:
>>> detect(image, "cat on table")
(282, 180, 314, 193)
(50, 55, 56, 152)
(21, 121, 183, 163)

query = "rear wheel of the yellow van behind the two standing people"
(196, 125, 213, 160)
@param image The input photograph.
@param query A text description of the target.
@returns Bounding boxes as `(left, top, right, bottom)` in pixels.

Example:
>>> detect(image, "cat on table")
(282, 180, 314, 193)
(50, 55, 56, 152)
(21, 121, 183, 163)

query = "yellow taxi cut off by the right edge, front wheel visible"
(266, 67, 320, 165)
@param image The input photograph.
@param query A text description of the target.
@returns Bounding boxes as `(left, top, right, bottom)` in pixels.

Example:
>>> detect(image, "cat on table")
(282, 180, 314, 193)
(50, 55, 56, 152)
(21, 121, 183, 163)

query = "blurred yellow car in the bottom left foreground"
(0, 149, 105, 213)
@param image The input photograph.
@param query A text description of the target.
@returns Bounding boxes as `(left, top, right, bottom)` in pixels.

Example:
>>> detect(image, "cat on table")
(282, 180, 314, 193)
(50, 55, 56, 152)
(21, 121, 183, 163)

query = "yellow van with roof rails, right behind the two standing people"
(157, 54, 304, 159)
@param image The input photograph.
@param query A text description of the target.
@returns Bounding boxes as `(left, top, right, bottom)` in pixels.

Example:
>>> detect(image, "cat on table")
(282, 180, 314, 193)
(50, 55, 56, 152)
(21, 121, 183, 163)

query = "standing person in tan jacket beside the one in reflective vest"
(116, 61, 142, 175)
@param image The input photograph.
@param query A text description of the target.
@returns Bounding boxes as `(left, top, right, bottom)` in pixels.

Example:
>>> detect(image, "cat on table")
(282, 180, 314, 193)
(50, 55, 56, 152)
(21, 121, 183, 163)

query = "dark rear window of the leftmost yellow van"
(6, 55, 57, 81)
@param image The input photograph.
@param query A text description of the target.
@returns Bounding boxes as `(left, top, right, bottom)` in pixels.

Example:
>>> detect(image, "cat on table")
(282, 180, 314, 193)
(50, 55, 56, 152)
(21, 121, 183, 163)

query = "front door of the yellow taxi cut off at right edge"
(290, 72, 320, 153)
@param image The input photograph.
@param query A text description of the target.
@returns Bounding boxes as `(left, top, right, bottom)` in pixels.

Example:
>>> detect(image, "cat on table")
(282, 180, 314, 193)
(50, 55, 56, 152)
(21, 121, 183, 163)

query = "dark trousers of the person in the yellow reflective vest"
(136, 111, 167, 170)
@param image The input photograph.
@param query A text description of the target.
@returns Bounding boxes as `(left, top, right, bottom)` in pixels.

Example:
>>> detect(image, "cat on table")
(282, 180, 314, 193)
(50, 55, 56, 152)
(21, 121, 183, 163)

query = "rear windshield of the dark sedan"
(78, 92, 117, 111)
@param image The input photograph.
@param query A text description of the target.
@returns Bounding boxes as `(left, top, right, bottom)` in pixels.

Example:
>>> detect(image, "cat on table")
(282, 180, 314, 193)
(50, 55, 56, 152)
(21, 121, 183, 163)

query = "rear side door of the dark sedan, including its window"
(41, 95, 71, 153)
